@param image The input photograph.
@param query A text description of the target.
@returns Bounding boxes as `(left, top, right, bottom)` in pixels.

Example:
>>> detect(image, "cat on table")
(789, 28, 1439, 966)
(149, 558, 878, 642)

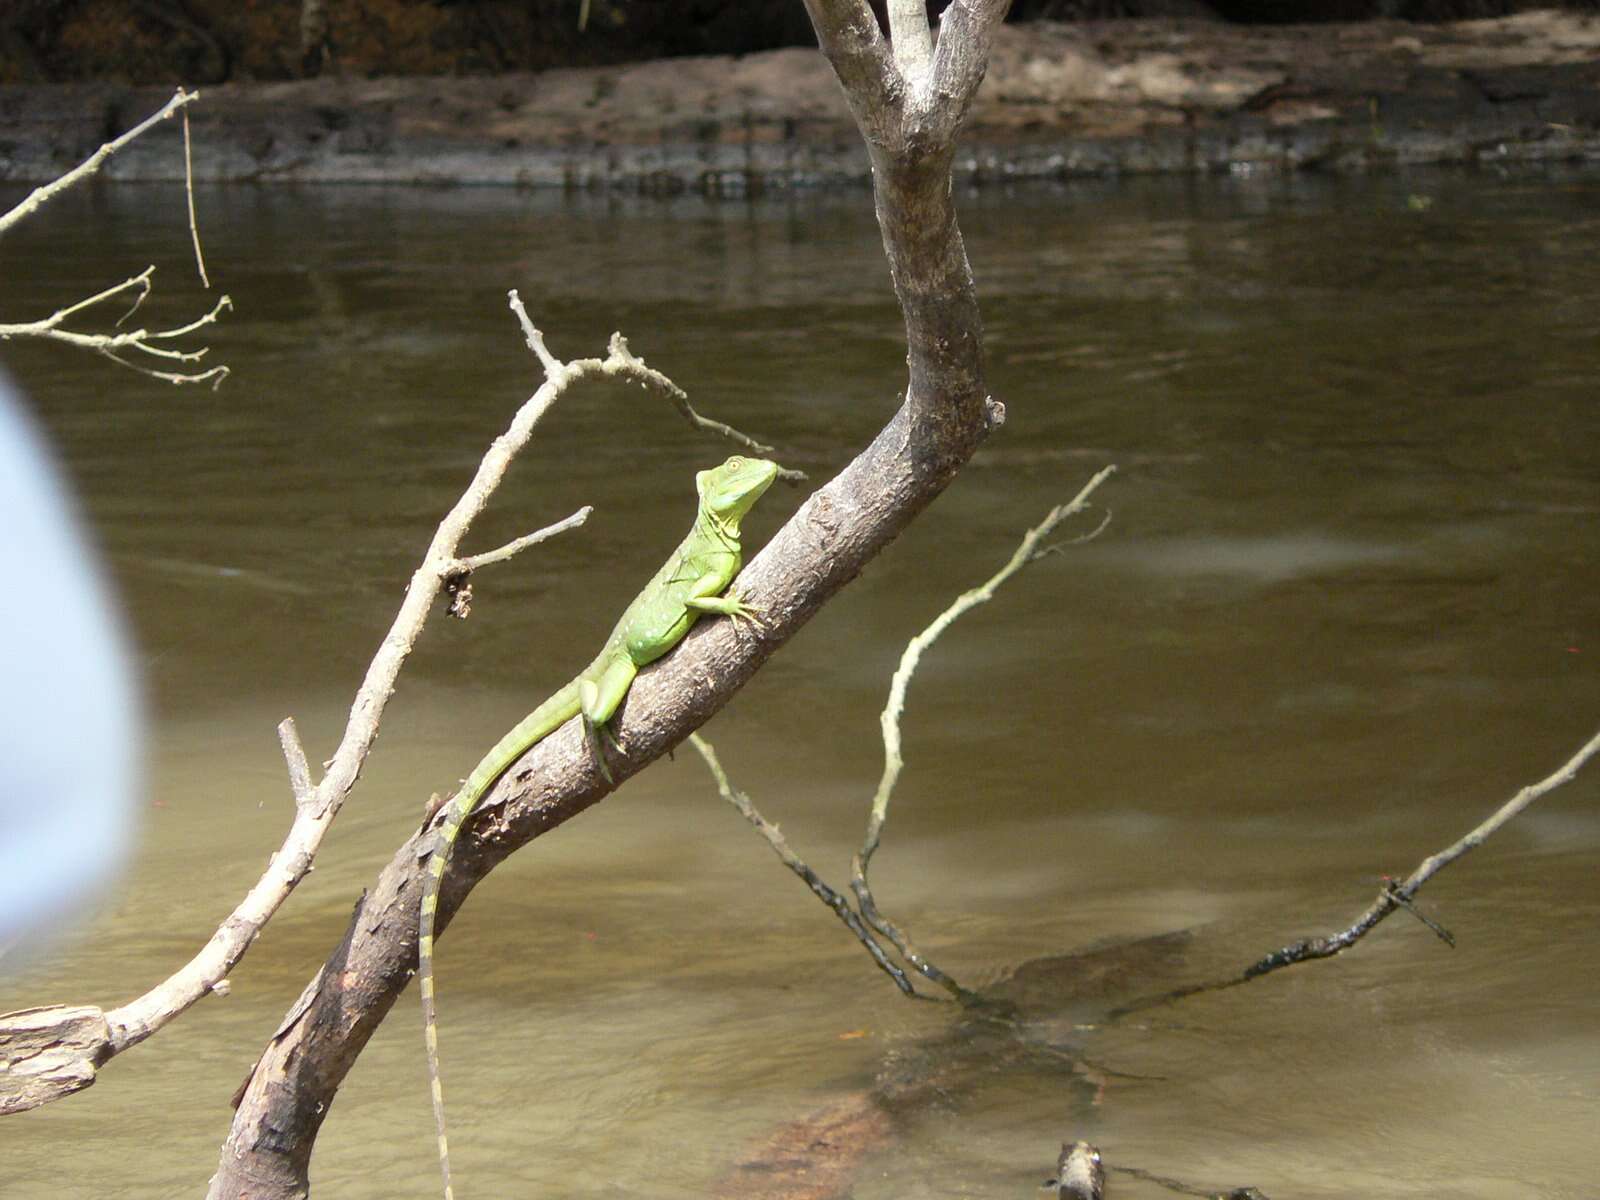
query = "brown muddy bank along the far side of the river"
(0, 11, 1600, 194)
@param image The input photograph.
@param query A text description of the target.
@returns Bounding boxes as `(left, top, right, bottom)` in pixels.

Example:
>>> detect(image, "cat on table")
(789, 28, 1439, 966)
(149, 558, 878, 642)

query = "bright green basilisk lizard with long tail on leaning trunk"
(416, 454, 778, 1200)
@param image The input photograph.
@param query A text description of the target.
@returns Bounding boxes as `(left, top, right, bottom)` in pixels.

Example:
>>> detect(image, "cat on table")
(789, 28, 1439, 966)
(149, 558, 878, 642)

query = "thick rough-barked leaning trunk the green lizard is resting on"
(210, 0, 1008, 1200)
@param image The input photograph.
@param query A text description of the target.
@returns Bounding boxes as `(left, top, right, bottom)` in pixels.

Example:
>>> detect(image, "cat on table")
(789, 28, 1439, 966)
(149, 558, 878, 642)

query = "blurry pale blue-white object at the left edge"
(0, 374, 141, 950)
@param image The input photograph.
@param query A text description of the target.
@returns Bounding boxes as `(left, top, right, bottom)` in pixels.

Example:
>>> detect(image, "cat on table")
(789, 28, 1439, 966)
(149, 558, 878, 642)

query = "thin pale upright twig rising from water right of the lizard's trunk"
(850, 467, 1115, 998)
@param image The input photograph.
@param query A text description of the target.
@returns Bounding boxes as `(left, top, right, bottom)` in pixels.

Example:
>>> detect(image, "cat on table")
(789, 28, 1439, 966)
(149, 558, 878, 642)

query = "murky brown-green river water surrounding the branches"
(0, 174, 1600, 1200)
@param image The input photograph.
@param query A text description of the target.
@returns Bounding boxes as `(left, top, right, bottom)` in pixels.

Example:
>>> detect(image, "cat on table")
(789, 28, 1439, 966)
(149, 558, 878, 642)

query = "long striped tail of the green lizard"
(416, 680, 579, 1200)
